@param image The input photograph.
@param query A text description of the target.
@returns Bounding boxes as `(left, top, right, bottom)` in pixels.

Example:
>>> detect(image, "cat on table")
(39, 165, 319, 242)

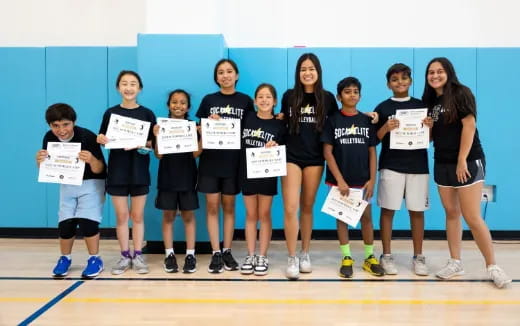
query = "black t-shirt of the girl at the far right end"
(430, 96, 484, 164)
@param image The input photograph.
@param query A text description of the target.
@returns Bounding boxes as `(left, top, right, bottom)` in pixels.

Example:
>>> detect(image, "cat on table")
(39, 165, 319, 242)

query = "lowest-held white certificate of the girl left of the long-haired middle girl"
(246, 145, 287, 179)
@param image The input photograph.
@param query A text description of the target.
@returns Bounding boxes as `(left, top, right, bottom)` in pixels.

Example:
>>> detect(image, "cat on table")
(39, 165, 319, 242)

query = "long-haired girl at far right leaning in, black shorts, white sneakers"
(422, 58, 511, 288)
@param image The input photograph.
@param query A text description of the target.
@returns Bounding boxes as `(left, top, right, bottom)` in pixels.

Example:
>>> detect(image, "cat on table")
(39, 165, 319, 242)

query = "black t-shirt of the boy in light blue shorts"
(42, 126, 107, 180)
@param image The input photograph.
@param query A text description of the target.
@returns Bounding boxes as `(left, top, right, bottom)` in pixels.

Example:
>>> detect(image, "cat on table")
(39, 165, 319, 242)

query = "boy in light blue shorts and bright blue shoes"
(36, 103, 106, 278)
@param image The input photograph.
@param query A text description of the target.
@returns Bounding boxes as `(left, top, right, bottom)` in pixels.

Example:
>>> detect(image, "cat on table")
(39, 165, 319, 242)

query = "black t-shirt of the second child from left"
(99, 105, 156, 186)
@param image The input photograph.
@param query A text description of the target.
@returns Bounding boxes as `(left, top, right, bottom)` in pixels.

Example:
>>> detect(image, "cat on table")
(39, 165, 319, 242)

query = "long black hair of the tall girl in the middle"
(289, 53, 326, 134)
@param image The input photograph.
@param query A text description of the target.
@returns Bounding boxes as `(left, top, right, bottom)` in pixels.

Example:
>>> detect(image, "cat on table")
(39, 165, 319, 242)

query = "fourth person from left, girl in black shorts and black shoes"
(197, 59, 254, 273)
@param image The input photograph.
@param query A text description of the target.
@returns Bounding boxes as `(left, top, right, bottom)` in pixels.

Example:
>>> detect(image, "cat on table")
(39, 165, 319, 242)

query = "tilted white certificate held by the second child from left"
(105, 113, 150, 149)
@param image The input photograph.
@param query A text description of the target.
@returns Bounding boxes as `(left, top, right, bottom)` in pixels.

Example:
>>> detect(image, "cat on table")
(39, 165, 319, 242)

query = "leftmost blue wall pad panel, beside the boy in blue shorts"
(0, 48, 48, 227)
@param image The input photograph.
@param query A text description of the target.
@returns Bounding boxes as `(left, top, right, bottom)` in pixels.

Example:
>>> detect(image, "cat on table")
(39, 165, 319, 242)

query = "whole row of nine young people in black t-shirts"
(37, 53, 511, 288)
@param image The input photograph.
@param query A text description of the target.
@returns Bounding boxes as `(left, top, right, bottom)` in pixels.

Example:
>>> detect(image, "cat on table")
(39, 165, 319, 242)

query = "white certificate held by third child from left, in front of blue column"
(157, 118, 199, 154)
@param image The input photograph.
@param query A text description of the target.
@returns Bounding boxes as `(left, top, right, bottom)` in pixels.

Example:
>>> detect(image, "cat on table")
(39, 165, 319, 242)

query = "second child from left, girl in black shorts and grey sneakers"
(97, 70, 155, 275)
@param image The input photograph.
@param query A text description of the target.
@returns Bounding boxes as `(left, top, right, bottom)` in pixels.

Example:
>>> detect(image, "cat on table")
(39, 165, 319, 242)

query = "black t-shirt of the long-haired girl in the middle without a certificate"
(282, 89, 338, 162)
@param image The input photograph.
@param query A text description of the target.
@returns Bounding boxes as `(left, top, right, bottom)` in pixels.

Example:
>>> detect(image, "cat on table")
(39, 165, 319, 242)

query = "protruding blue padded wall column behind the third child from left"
(137, 35, 228, 241)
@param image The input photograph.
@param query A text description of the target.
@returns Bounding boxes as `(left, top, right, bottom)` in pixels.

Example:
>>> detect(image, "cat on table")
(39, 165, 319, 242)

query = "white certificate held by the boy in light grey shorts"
(390, 109, 430, 149)
